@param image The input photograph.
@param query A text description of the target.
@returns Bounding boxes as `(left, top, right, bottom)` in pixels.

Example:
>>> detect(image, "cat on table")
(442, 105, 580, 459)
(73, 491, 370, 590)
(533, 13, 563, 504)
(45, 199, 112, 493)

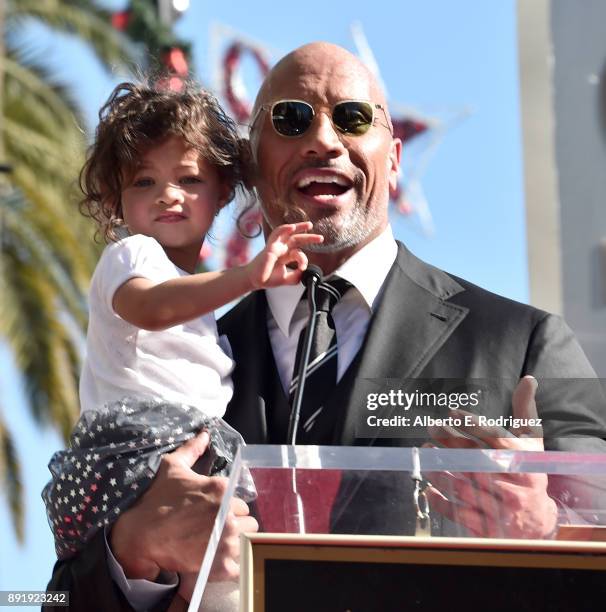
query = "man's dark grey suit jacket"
(49, 244, 606, 610)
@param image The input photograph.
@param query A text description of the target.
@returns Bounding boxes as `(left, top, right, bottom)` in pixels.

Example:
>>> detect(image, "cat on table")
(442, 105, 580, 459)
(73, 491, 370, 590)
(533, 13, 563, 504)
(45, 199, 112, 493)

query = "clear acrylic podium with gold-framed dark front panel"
(189, 445, 606, 612)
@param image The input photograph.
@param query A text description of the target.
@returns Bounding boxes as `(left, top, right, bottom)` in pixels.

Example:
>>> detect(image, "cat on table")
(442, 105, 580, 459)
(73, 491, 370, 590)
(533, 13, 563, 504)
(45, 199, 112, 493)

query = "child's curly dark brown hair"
(79, 82, 248, 242)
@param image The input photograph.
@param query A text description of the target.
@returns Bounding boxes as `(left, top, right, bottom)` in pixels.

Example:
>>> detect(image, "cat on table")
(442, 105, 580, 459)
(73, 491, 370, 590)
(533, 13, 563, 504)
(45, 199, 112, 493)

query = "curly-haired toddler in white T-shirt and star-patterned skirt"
(43, 83, 322, 604)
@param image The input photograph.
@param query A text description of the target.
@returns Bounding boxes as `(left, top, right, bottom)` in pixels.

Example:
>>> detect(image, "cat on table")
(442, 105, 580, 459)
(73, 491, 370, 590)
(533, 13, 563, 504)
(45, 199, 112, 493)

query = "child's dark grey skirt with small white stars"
(42, 398, 255, 559)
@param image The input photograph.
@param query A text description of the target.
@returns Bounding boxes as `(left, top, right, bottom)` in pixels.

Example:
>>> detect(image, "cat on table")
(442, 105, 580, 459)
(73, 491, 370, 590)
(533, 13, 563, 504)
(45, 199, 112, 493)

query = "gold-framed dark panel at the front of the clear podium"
(240, 533, 606, 612)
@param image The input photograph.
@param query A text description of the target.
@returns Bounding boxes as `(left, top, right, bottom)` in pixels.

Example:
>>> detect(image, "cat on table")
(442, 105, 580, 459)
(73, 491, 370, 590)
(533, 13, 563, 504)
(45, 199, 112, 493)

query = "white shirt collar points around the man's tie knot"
(265, 225, 398, 336)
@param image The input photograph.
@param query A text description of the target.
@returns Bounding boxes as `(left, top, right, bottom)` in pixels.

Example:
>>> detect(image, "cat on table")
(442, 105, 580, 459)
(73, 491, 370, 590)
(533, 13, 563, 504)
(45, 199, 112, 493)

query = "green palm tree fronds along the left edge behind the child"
(0, 0, 145, 539)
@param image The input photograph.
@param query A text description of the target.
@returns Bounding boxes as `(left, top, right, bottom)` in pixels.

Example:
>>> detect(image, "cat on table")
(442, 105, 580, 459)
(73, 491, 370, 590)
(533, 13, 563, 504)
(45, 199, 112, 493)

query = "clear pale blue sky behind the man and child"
(0, 0, 528, 604)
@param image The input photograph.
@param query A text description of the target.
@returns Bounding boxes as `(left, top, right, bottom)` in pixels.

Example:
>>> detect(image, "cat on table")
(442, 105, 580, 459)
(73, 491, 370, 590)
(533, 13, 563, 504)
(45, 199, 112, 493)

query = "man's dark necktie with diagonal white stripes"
(289, 278, 352, 442)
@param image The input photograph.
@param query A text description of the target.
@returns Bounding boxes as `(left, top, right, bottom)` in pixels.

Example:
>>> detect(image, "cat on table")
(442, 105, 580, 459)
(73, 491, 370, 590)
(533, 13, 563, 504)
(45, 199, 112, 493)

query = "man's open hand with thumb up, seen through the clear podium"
(426, 376, 558, 538)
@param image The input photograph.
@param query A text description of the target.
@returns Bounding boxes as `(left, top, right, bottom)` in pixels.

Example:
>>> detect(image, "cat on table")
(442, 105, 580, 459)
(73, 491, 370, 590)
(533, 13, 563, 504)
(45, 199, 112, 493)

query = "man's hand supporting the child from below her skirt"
(110, 432, 258, 580)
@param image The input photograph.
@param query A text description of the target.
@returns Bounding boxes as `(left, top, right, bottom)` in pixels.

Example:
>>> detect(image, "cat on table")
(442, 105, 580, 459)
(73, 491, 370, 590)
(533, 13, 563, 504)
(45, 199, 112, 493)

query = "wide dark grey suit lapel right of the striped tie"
(335, 244, 468, 445)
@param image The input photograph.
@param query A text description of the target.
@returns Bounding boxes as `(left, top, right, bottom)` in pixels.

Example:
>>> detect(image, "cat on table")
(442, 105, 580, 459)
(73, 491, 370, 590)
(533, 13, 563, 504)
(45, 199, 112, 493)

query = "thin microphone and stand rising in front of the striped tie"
(287, 265, 323, 533)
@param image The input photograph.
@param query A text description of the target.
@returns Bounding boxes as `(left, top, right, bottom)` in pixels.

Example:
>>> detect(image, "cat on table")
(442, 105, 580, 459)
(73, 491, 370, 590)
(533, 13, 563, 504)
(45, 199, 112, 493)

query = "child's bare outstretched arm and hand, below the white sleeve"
(112, 222, 323, 331)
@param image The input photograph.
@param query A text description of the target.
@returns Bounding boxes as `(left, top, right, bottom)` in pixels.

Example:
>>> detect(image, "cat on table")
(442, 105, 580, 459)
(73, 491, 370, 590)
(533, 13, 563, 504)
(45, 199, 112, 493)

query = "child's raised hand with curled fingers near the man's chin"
(246, 221, 324, 289)
